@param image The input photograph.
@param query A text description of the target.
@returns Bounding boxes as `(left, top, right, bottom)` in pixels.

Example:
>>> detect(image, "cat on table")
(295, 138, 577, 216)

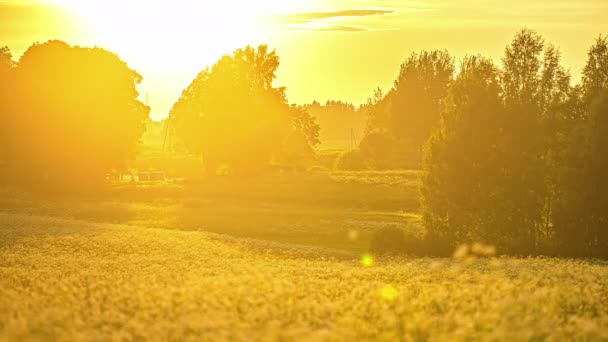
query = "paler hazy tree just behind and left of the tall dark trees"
(361, 50, 454, 169)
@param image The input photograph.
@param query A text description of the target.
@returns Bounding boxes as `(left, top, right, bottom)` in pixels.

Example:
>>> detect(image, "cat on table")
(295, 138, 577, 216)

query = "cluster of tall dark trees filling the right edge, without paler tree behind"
(422, 30, 608, 256)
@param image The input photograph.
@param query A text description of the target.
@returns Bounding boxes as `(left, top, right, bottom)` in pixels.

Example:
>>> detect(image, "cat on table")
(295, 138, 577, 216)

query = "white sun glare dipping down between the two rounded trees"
(30, 0, 338, 119)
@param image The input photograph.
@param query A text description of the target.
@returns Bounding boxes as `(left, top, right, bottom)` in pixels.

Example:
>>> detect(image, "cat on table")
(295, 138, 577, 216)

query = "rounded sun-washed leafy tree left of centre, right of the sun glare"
(170, 45, 319, 174)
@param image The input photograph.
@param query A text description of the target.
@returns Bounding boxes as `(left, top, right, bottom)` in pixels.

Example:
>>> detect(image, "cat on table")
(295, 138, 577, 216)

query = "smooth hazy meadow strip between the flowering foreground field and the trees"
(0, 171, 421, 252)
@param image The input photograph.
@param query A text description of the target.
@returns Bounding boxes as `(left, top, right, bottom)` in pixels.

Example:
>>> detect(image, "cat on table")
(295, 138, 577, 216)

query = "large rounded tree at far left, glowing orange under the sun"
(5, 41, 149, 186)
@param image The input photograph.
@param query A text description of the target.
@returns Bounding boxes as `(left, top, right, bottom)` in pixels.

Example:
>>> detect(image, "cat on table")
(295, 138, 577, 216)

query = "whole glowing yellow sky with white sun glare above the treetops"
(0, 0, 608, 118)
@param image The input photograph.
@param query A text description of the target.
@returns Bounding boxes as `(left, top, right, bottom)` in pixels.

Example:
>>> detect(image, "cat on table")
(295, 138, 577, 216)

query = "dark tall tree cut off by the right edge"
(554, 37, 608, 257)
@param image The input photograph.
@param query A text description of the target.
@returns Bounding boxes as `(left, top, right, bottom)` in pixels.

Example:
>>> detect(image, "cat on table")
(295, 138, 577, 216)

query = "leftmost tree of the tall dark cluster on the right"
(422, 56, 504, 246)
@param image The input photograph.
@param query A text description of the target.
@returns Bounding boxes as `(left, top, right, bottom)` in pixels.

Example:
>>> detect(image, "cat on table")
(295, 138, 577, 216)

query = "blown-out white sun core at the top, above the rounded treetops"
(36, 0, 310, 71)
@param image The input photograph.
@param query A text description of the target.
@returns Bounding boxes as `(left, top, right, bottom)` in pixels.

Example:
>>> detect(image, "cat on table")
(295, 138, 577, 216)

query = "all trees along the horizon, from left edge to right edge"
(0, 29, 608, 257)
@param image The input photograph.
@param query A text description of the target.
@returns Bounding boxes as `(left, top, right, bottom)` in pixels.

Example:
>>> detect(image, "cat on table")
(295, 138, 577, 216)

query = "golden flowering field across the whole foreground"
(0, 212, 608, 341)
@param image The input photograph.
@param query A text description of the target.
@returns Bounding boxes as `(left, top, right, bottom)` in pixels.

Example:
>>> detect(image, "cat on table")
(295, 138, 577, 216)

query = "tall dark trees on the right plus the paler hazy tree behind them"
(337, 29, 608, 257)
